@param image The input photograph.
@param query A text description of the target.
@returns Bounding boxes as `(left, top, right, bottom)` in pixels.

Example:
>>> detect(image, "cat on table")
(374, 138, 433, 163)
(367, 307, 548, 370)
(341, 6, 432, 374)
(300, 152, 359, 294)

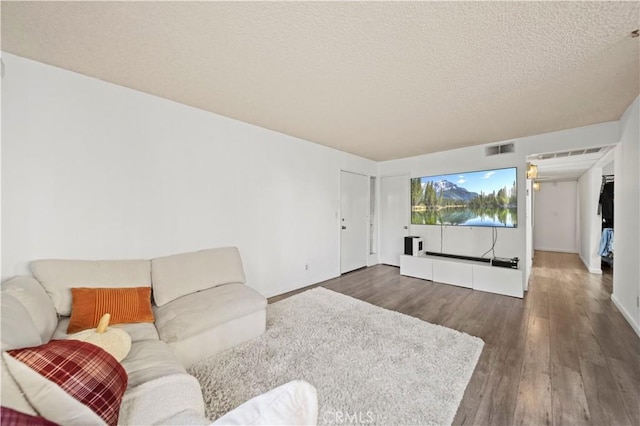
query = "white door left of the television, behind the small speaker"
(380, 175, 411, 266)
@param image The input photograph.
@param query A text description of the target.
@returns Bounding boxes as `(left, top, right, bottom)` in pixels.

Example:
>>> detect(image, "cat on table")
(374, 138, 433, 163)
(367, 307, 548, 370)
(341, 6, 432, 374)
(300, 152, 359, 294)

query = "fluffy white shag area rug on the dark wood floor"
(189, 287, 484, 425)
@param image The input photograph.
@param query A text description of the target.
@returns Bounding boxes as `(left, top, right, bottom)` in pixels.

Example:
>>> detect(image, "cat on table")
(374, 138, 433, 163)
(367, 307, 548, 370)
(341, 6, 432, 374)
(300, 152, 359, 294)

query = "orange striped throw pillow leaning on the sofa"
(67, 287, 155, 334)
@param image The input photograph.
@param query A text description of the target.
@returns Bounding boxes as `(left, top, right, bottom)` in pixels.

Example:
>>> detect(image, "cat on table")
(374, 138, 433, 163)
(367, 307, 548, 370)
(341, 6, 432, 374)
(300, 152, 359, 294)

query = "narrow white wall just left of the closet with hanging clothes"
(578, 167, 602, 274)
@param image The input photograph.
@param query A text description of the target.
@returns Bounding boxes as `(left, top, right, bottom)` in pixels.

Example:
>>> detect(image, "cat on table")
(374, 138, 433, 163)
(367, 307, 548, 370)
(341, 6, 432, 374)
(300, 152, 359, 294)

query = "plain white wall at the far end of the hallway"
(533, 181, 578, 253)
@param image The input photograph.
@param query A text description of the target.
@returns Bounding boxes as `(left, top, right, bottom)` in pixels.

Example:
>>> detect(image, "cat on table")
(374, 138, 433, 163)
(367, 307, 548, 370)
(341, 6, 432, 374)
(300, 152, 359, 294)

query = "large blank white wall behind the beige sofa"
(2, 54, 377, 296)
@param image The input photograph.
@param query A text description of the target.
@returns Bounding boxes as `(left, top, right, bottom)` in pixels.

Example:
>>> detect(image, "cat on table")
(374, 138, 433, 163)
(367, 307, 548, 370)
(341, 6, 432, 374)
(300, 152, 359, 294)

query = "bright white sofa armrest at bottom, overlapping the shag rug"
(212, 380, 318, 425)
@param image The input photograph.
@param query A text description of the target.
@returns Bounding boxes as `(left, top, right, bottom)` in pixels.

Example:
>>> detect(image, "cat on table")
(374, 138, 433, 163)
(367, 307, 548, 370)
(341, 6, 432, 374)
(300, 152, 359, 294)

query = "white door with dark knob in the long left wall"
(340, 172, 369, 274)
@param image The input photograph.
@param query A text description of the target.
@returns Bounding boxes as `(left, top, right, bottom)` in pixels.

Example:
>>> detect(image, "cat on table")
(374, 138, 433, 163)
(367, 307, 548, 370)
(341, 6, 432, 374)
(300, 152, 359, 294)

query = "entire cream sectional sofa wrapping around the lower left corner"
(1, 247, 317, 424)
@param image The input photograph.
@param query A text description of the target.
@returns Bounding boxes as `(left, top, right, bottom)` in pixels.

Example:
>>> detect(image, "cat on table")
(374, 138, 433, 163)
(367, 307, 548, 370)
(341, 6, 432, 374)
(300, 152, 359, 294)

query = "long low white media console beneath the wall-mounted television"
(400, 255, 523, 298)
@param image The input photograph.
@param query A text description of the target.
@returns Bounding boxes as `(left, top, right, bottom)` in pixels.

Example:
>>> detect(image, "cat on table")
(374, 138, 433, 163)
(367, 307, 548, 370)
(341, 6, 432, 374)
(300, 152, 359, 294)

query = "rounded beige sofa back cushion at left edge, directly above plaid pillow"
(0, 292, 42, 352)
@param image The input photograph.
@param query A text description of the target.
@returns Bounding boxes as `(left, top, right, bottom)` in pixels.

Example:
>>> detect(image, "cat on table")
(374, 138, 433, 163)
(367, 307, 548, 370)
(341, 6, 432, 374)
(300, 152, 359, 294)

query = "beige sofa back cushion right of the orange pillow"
(151, 247, 245, 306)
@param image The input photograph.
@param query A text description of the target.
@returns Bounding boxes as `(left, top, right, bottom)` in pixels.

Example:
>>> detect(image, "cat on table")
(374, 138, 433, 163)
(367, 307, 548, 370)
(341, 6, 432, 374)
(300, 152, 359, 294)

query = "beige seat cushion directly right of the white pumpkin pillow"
(122, 340, 187, 388)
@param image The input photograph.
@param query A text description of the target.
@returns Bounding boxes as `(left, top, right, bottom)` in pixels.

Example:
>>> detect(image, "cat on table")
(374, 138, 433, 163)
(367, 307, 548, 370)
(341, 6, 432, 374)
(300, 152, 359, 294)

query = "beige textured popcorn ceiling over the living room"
(2, 1, 640, 160)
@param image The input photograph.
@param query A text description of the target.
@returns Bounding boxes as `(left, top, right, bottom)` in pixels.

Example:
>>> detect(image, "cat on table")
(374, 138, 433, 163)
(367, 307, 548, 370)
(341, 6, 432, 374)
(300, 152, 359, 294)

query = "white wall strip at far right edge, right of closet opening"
(611, 98, 640, 335)
